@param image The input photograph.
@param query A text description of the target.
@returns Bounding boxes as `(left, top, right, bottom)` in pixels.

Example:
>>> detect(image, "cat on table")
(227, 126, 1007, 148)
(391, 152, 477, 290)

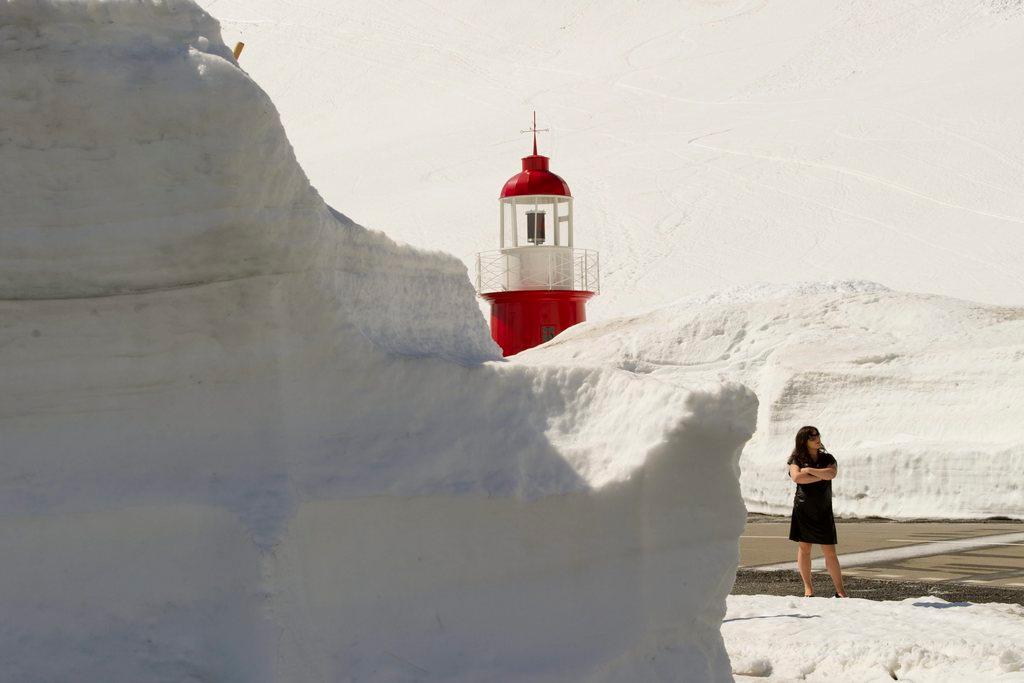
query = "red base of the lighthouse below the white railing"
(480, 290, 594, 355)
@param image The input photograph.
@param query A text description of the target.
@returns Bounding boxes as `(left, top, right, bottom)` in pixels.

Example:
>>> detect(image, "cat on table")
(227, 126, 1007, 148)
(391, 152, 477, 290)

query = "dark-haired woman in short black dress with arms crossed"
(787, 427, 846, 598)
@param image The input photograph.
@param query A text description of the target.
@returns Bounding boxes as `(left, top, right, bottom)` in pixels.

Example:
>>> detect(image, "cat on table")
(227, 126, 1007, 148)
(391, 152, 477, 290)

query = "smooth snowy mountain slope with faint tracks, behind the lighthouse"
(205, 0, 1024, 318)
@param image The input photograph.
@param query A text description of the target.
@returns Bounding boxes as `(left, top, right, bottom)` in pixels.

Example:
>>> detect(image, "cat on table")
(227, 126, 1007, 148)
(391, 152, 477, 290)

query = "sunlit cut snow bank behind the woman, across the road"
(519, 282, 1024, 518)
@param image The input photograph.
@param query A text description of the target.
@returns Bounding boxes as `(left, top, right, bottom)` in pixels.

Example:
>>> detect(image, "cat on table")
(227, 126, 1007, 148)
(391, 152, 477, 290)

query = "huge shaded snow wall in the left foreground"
(0, 0, 757, 683)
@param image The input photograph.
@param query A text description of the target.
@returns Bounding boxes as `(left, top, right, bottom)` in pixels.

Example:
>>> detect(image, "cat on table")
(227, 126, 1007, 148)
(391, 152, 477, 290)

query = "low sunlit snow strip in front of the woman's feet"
(722, 595, 1024, 683)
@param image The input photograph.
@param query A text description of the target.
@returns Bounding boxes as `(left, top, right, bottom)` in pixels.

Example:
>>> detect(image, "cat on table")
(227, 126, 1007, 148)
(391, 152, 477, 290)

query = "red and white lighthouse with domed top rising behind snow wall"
(476, 113, 600, 355)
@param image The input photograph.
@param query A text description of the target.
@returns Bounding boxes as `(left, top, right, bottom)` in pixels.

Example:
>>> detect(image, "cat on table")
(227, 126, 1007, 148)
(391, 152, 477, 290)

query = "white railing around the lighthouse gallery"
(476, 247, 601, 294)
